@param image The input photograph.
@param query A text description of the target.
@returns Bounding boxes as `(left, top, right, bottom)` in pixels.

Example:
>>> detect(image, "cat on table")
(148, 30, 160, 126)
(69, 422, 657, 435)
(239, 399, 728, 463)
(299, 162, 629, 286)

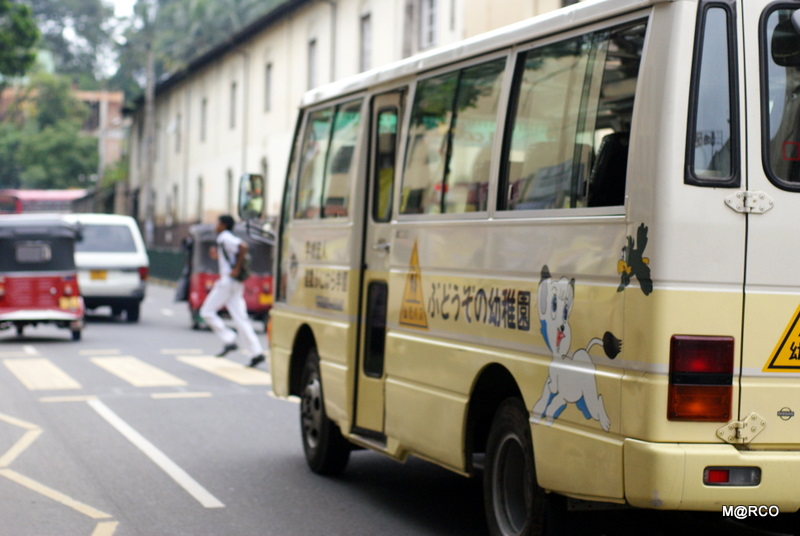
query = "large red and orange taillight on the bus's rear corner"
(667, 335, 733, 422)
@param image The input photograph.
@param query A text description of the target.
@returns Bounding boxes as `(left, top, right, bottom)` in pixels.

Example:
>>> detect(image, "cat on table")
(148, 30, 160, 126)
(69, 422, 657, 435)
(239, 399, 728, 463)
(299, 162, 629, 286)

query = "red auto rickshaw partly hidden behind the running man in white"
(177, 223, 272, 329)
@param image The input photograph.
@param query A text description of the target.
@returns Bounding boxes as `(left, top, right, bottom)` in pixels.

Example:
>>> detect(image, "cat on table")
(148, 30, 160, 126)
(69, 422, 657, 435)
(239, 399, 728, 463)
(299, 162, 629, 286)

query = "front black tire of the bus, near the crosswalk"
(300, 348, 350, 475)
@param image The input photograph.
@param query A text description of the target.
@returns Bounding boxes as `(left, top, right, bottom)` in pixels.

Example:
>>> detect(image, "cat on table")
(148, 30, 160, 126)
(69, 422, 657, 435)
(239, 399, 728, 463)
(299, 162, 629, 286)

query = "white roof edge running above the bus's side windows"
(301, 0, 674, 108)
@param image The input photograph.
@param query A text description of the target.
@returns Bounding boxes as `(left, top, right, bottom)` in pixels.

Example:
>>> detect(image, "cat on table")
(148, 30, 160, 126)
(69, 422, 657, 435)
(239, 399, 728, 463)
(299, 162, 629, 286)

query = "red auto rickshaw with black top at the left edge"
(0, 214, 84, 341)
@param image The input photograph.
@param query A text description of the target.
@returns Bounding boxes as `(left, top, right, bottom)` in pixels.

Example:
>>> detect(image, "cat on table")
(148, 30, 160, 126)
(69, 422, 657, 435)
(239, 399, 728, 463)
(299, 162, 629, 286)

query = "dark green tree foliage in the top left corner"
(0, 0, 39, 76)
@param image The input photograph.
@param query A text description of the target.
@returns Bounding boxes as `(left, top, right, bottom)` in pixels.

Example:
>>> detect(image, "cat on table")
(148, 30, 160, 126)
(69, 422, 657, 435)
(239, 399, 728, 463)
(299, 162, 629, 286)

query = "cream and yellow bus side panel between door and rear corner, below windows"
(386, 216, 635, 499)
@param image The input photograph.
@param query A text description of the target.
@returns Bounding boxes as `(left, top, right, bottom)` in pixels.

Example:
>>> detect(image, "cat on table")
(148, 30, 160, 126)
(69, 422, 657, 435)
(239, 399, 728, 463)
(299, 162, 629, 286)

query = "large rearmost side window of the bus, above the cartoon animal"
(498, 24, 645, 210)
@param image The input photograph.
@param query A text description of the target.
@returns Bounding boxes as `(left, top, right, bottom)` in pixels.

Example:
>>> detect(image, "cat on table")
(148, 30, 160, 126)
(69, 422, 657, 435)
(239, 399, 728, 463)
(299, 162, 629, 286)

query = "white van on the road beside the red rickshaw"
(64, 214, 150, 322)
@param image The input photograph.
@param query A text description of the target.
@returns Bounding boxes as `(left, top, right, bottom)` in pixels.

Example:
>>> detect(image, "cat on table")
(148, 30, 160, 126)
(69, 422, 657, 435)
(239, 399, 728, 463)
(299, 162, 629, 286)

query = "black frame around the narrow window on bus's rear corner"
(683, 0, 742, 188)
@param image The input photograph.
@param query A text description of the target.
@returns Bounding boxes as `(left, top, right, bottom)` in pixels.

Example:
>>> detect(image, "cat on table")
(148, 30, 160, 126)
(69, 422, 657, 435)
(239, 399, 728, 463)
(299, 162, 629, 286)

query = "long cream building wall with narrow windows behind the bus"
(130, 0, 576, 242)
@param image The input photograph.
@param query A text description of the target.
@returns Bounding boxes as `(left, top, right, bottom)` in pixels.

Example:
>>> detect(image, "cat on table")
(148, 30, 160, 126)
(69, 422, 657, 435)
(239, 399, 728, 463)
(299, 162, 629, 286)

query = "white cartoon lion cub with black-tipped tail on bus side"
(531, 265, 622, 432)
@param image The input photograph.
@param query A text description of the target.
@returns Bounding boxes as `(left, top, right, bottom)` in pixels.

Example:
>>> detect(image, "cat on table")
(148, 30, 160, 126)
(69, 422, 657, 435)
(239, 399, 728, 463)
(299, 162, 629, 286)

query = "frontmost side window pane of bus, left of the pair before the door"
(294, 108, 333, 219)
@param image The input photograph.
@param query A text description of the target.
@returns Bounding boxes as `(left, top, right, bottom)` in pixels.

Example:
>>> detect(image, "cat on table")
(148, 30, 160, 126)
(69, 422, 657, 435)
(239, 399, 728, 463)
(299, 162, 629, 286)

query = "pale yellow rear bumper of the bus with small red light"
(624, 439, 800, 513)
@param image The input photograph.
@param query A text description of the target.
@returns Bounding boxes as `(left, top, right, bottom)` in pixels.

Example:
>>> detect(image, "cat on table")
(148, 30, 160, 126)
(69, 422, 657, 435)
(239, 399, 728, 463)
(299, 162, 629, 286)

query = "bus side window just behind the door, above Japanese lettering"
(401, 58, 506, 214)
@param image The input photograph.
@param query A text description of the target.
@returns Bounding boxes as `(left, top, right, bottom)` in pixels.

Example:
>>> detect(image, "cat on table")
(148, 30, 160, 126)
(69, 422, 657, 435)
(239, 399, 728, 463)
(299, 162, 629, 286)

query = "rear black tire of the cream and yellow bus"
(483, 398, 548, 536)
